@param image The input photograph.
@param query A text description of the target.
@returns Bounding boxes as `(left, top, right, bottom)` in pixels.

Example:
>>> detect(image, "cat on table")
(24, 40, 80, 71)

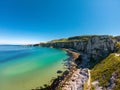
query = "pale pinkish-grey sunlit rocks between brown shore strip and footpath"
(62, 69, 88, 90)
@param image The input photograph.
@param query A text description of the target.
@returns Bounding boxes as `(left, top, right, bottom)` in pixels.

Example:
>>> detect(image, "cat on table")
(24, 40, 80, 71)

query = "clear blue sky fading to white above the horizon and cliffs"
(0, 0, 120, 44)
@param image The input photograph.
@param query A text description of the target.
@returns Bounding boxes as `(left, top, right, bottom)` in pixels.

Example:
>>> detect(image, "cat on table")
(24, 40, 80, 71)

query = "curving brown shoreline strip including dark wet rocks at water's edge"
(31, 48, 80, 90)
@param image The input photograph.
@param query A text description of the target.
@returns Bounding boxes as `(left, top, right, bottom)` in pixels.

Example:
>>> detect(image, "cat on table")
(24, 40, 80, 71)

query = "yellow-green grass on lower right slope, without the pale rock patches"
(91, 53, 120, 90)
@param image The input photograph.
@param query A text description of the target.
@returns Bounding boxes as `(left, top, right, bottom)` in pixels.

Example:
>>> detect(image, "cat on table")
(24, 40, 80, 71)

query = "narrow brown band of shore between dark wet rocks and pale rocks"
(55, 48, 80, 90)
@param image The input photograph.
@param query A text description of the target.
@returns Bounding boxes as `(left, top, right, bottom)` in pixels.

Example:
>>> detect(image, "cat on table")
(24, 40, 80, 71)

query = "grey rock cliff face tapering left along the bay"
(40, 35, 116, 61)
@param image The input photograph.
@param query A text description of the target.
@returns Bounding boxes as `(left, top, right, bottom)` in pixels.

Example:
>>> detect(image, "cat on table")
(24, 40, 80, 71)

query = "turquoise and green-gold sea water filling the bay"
(0, 46, 68, 90)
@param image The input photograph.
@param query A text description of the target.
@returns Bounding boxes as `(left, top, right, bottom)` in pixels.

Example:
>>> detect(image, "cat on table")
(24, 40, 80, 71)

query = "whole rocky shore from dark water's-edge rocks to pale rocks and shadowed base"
(32, 49, 89, 90)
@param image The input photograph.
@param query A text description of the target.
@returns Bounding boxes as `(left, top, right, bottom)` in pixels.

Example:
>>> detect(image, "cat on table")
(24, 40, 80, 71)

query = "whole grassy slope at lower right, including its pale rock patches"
(91, 52, 120, 90)
